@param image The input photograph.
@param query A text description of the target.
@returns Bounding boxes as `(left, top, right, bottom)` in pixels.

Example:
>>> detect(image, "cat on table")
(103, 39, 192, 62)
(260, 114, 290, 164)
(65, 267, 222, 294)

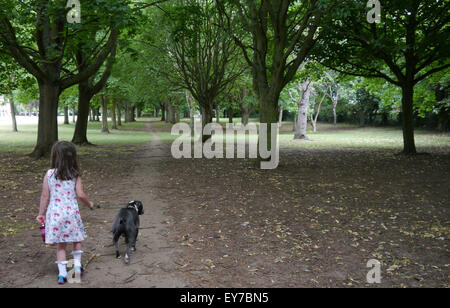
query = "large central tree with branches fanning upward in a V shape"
(216, 0, 335, 148)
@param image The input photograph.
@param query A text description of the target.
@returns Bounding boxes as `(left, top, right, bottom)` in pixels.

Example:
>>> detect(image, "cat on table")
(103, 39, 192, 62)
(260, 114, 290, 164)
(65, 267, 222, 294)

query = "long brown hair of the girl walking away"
(51, 141, 81, 181)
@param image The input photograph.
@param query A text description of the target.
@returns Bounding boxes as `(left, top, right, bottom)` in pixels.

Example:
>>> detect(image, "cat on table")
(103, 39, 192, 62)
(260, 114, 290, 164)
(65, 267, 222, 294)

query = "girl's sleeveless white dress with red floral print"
(45, 169, 87, 244)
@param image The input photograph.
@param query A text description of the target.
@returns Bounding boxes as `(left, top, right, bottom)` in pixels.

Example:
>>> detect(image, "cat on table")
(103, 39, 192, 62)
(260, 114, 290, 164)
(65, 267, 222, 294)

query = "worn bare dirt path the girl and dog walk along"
(23, 124, 187, 287)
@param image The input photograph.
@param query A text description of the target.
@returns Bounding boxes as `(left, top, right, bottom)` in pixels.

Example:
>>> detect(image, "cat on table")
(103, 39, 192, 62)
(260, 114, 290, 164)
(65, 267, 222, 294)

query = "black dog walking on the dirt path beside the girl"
(112, 201, 144, 263)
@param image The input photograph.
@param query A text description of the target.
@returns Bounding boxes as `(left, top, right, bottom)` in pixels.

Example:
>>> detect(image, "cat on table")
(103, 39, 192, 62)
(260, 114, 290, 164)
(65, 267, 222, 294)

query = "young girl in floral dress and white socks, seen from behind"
(36, 141, 94, 284)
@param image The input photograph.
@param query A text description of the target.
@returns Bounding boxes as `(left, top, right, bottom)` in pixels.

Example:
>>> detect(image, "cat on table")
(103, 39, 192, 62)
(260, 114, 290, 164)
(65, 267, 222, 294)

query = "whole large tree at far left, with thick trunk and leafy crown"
(0, 0, 126, 158)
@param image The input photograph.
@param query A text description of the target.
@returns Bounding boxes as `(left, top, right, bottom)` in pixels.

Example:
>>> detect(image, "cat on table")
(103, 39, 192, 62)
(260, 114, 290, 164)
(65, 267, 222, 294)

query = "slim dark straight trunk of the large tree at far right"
(402, 82, 417, 154)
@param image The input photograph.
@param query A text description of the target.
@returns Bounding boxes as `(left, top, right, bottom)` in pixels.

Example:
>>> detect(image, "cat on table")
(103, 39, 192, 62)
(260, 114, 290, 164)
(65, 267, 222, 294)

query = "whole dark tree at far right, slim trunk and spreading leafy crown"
(315, 0, 450, 154)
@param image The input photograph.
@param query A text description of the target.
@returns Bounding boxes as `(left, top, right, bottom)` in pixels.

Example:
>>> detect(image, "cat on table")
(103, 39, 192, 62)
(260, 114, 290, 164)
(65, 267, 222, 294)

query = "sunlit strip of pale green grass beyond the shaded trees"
(0, 118, 450, 153)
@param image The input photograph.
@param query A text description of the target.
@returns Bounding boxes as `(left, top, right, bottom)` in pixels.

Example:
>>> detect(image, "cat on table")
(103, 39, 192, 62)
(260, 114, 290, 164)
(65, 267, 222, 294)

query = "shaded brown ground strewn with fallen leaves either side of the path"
(0, 122, 450, 287)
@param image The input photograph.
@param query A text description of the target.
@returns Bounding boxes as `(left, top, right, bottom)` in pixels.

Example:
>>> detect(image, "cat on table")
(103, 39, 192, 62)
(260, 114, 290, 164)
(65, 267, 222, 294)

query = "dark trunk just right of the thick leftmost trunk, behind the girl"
(72, 81, 94, 145)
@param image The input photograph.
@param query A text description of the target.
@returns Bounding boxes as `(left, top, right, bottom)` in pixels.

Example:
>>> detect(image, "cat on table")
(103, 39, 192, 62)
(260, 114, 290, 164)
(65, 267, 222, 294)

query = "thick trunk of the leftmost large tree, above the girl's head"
(31, 81, 60, 158)
